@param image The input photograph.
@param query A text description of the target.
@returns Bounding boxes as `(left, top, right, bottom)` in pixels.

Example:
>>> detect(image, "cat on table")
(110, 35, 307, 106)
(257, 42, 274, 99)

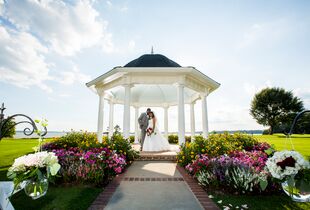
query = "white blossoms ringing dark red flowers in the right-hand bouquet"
(266, 150, 310, 179)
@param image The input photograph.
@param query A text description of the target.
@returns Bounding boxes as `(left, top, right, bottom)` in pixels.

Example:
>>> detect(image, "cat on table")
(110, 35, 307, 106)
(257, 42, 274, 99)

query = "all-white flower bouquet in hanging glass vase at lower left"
(7, 151, 60, 199)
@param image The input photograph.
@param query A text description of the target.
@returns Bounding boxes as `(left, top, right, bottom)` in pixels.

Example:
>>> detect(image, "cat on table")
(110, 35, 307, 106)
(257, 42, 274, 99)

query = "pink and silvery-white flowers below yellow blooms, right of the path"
(185, 150, 276, 193)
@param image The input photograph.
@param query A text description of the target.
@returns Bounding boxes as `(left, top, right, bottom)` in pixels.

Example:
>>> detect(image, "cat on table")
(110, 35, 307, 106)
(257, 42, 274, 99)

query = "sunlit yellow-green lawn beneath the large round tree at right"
(255, 134, 310, 157)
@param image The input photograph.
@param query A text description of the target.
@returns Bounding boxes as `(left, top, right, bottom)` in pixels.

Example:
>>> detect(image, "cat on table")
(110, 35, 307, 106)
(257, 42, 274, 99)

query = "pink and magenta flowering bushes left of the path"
(53, 147, 127, 185)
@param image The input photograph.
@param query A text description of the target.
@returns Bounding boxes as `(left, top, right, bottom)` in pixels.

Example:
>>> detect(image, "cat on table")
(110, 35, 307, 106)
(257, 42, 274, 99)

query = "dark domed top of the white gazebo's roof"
(124, 54, 181, 67)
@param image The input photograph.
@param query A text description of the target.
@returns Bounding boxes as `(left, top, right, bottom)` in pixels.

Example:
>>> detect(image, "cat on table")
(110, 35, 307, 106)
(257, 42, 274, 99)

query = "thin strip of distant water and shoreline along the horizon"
(14, 130, 263, 139)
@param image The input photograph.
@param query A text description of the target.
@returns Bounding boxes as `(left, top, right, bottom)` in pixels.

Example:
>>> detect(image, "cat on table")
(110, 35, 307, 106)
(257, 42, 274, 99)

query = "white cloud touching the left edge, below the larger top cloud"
(0, 25, 52, 92)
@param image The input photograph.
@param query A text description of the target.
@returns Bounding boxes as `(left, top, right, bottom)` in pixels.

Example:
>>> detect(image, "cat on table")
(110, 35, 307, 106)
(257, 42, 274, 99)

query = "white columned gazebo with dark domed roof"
(86, 53, 220, 144)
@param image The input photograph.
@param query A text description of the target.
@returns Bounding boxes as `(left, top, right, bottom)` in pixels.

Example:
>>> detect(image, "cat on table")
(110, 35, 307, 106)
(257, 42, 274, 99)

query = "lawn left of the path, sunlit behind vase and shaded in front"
(0, 139, 102, 210)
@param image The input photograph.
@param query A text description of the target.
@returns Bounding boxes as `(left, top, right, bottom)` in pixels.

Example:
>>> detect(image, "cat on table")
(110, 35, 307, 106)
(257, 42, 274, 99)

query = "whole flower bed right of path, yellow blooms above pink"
(177, 133, 310, 199)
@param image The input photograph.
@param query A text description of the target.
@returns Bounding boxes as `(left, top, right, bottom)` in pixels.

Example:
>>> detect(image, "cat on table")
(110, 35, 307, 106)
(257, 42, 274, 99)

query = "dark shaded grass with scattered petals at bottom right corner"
(208, 192, 310, 210)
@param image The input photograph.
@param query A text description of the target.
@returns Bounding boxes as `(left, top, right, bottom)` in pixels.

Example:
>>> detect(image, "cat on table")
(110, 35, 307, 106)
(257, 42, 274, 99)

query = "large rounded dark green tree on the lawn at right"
(250, 88, 304, 134)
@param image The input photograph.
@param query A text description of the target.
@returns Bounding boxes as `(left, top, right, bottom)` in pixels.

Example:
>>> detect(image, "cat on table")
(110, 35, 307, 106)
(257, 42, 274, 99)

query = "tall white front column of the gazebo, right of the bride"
(177, 84, 185, 145)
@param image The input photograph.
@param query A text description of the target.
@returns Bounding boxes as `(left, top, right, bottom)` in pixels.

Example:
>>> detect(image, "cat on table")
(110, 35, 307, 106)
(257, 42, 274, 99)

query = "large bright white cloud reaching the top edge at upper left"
(3, 0, 113, 56)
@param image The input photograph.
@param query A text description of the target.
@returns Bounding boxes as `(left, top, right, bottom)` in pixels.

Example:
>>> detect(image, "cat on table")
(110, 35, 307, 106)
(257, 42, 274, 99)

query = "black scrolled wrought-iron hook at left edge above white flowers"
(0, 103, 47, 141)
